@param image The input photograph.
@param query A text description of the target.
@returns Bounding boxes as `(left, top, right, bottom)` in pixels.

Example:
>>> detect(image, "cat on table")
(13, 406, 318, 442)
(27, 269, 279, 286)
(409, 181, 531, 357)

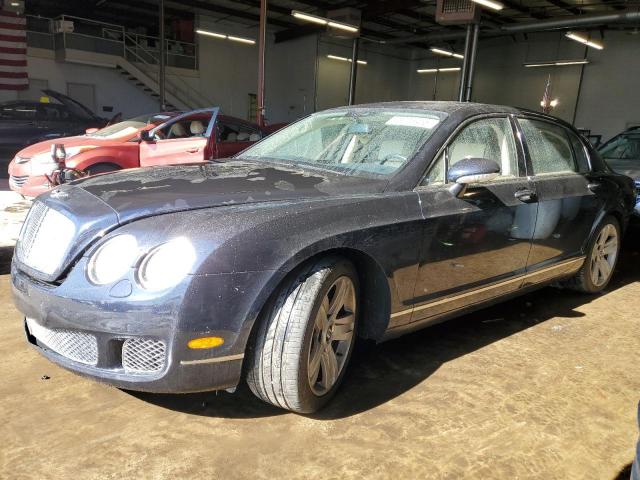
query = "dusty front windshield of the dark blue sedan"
(238, 108, 446, 177)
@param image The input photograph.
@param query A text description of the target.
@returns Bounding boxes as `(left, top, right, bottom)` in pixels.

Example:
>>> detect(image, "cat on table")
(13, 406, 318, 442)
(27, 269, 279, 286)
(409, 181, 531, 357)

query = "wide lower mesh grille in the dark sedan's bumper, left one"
(27, 318, 98, 366)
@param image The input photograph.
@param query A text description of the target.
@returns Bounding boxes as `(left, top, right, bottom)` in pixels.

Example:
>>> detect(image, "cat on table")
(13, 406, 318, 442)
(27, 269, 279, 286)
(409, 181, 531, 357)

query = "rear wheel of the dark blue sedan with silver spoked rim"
(566, 215, 622, 294)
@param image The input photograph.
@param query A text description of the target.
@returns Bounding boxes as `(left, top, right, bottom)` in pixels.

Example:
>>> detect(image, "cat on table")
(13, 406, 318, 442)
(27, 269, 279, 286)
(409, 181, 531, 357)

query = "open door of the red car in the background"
(140, 108, 219, 167)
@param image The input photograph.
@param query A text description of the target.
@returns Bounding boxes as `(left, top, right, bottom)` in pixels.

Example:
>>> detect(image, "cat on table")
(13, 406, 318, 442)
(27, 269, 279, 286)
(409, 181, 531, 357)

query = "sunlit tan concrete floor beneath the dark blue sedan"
(0, 234, 640, 480)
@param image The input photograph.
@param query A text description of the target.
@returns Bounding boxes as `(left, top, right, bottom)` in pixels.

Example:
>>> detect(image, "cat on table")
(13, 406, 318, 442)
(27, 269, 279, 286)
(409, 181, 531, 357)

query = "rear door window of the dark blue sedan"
(518, 119, 577, 175)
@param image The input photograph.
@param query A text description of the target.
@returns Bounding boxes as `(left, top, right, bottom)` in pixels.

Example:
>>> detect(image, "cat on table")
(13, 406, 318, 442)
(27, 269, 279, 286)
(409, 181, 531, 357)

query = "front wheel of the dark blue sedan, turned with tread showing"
(247, 258, 359, 413)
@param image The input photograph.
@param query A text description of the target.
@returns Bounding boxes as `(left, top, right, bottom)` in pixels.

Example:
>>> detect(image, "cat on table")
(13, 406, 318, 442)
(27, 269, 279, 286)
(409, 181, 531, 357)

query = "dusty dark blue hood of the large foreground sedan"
(74, 160, 387, 223)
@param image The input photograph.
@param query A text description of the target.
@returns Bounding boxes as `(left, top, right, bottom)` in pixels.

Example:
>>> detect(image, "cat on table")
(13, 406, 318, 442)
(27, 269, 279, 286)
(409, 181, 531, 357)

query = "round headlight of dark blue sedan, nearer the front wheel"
(138, 237, 196, 291)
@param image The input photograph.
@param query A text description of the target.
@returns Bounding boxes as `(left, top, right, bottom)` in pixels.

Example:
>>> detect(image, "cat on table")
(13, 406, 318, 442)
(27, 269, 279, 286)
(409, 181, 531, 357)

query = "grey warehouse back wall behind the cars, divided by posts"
(6, 17, 640, 139)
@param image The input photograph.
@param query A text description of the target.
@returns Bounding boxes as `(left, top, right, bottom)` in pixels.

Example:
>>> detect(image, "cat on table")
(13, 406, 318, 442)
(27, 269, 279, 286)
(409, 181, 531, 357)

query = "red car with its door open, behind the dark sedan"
(9, 108, 270, 197)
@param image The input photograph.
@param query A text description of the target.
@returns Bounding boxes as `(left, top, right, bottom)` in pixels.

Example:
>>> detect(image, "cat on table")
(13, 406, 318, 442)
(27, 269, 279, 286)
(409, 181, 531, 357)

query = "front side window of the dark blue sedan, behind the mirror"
(422, 117, 519, 185)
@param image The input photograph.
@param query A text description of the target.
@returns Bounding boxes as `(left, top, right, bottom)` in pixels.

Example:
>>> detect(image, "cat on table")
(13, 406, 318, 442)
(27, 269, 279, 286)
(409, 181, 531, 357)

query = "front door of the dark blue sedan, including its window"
(412, 116, 538, 321)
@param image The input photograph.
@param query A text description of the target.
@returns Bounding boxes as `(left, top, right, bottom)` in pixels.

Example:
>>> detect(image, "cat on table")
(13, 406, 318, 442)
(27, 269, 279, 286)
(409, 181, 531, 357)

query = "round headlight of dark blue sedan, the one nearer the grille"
(87, 235, 138, 285)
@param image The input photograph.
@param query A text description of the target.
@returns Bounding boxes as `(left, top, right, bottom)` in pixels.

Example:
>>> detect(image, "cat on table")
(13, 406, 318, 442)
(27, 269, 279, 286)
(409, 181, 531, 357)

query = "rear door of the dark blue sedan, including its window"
(517, 117, 606, 281)
